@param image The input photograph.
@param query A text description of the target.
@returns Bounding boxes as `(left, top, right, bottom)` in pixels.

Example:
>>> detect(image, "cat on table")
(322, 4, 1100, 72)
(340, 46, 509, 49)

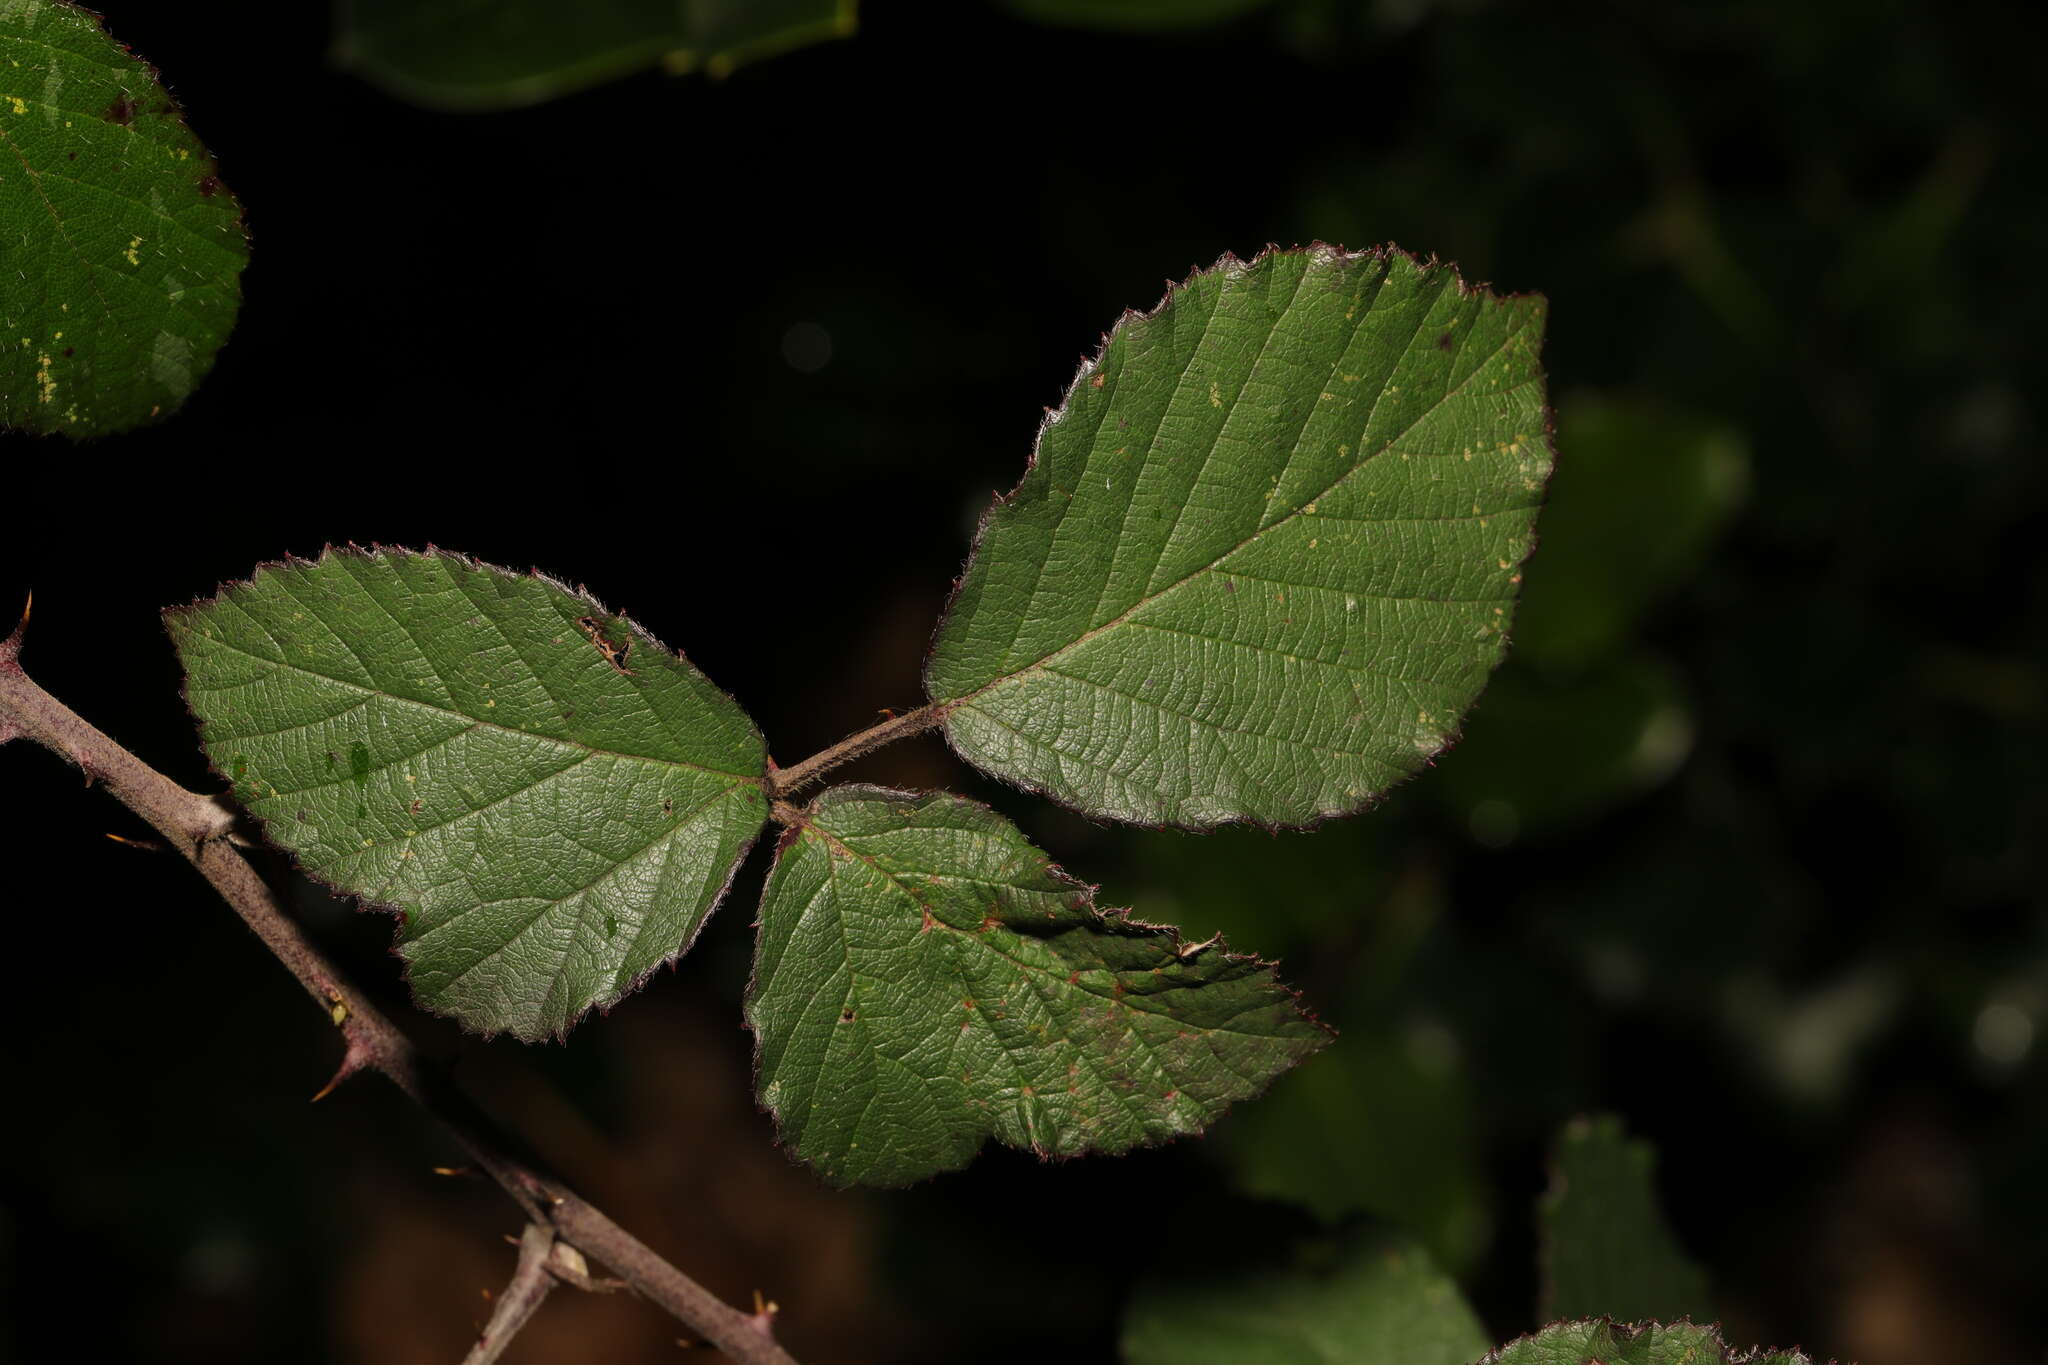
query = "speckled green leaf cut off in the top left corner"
(0, 0, 248, 436)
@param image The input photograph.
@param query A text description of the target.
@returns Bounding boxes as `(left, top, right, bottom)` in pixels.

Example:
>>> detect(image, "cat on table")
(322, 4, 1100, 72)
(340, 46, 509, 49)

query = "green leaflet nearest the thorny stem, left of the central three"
(166, 548, 766, 1040)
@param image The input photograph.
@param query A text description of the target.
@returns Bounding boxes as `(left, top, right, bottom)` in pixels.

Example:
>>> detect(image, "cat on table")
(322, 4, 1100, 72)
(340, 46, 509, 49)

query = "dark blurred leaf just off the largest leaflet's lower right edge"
(1430, 651, 1692, 847)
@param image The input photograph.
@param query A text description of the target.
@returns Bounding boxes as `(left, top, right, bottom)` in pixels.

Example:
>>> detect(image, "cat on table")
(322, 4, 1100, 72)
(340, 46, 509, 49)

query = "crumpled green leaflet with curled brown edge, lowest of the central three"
(748, 786, 1327, 1185)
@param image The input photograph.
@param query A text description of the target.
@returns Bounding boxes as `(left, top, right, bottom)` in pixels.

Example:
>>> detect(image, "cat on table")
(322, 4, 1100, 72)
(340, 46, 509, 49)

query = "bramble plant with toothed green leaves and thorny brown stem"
(0, 0, 1859, 1365)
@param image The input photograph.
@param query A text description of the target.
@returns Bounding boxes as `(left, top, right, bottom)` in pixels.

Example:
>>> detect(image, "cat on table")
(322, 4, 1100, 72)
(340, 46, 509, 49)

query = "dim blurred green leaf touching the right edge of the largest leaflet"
(1513, 393, 1749, 669)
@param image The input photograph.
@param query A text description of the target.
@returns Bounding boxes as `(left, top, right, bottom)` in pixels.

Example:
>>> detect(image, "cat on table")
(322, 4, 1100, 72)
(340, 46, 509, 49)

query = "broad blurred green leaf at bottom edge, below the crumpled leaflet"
(1122, 1232, 1489, 1365)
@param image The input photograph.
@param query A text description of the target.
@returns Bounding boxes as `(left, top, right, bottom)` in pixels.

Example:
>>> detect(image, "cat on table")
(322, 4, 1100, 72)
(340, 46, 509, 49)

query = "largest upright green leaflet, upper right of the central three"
(926, 246, 1550, 829)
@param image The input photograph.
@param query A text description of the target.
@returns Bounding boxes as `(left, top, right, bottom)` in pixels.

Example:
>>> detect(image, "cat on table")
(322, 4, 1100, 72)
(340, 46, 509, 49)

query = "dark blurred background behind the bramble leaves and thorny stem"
(0, 0, 2048, 1365)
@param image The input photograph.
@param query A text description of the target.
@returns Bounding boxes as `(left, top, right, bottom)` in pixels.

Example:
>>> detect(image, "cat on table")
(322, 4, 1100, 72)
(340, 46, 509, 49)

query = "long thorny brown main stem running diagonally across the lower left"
(0, 638, 798, 1365)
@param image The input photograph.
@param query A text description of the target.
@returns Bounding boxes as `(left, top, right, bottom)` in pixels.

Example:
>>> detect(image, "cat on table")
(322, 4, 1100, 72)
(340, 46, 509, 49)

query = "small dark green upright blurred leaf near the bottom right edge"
(1538, 1115, 1714, 1320)
